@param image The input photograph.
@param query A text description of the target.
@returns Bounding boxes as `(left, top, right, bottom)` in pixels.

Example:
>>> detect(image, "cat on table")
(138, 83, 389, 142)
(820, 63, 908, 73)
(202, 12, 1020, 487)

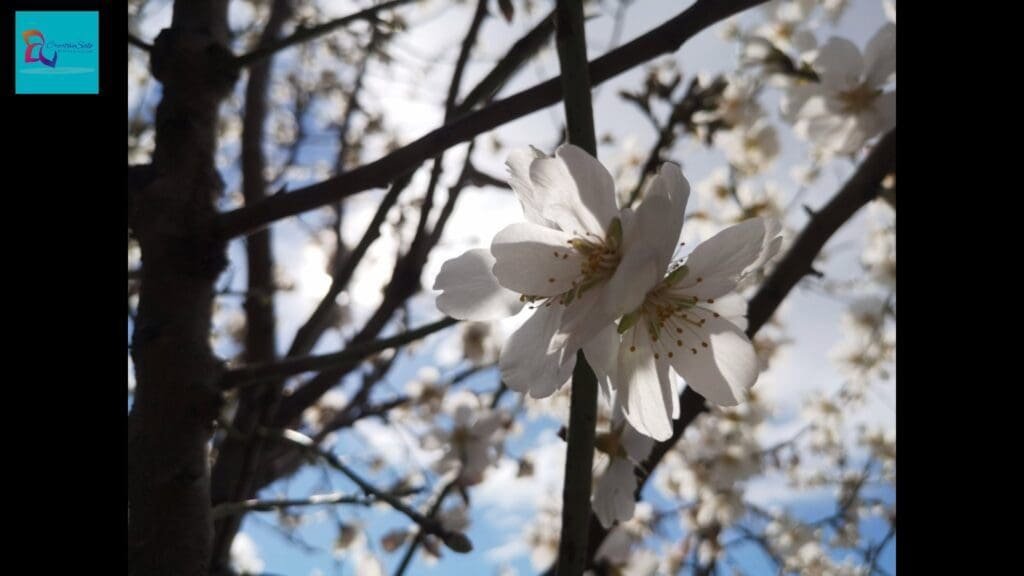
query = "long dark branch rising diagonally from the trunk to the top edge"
(218, 0, 766, 238)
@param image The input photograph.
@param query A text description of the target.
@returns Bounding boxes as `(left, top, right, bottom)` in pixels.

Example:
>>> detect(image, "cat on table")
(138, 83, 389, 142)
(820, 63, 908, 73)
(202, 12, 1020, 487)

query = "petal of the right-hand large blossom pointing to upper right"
(674, 214, 781, 299)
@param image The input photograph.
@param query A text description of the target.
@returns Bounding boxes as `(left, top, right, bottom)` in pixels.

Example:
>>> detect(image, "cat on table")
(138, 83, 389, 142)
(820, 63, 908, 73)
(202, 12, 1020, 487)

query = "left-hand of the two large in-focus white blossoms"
(434, 145, 689, 398)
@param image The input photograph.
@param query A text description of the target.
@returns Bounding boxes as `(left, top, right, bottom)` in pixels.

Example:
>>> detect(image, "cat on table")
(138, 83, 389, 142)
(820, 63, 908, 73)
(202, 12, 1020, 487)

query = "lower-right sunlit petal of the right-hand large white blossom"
(672, 311, 760, 406)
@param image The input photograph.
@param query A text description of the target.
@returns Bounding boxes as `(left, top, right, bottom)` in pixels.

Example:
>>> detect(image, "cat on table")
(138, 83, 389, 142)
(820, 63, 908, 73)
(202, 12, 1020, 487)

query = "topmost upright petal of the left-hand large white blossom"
(529, 145, 618, 238)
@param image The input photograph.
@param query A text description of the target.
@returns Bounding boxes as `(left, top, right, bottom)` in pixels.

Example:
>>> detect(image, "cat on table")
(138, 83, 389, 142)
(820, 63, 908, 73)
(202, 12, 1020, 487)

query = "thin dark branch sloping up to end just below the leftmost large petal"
(220, 318, 459, 390)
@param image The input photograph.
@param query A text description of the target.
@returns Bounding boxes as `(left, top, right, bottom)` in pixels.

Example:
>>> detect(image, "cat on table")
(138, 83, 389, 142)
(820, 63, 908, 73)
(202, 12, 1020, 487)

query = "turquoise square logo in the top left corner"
(14, 11, 99, 94)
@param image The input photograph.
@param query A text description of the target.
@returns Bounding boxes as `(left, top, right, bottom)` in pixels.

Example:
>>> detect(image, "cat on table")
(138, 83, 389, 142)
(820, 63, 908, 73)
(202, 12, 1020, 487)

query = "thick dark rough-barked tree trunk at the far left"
(127, 0, 237, 576)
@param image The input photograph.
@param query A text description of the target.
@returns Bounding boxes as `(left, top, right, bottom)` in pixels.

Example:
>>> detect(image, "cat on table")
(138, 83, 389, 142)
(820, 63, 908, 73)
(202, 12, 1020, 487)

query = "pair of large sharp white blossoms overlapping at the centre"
(434, 145, 781, 441)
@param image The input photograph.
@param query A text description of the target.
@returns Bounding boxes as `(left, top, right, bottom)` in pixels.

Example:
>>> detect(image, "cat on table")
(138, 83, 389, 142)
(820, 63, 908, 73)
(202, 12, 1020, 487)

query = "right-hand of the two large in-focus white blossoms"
(612, 216, 782, 441)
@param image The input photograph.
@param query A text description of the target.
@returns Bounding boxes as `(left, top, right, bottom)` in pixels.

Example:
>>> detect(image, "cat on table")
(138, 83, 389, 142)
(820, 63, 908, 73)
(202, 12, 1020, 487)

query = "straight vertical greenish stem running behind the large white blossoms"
(555, 0, 597, 576)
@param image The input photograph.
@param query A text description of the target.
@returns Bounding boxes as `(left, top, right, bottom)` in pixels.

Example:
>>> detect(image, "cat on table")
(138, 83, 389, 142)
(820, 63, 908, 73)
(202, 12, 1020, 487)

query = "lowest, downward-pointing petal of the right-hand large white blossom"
(617, 328, 678, 441)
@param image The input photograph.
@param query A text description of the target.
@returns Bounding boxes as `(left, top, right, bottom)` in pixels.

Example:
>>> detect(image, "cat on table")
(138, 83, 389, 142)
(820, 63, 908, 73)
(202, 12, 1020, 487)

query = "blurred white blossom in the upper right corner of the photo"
(794, 24, 896, 155)
